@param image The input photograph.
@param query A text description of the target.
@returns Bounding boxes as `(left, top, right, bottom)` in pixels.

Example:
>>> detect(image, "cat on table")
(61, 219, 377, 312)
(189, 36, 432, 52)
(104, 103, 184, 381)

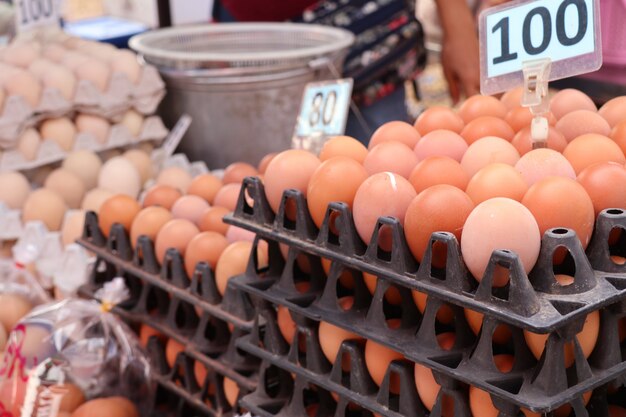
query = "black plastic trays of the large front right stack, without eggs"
(225, 178, 626, 417)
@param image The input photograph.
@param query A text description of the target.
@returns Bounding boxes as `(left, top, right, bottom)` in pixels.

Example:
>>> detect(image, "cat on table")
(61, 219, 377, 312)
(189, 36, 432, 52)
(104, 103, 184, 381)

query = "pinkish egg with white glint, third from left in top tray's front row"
(352, 172, 417, 250)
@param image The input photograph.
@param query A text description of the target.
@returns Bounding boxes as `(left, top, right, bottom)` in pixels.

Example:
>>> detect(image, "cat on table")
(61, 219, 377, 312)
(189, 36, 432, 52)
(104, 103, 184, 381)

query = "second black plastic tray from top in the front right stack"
(233, 249, 626, 417)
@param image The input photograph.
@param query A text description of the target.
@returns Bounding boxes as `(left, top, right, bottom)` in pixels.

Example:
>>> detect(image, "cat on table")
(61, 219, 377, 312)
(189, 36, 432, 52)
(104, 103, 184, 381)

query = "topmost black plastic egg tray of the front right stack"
(224, 177, 626, 333)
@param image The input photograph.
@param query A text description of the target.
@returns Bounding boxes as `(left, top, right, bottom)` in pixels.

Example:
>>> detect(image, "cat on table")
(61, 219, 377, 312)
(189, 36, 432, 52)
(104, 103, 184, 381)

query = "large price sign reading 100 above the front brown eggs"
(479, 0, 602, 94)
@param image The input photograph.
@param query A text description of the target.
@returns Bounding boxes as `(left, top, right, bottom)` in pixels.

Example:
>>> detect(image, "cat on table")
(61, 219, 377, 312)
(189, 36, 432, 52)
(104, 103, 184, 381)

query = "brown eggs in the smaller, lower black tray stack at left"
(94, 163, 268, 406)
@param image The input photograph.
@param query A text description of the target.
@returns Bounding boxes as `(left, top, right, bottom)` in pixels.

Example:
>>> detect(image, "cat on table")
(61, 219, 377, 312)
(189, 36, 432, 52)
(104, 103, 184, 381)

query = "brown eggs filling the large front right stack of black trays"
(240, 90, 626, 417)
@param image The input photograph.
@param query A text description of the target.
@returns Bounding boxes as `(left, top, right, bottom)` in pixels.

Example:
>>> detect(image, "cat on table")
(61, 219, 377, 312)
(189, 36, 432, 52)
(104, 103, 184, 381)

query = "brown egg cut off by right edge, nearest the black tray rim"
(577, 162, 626, 216)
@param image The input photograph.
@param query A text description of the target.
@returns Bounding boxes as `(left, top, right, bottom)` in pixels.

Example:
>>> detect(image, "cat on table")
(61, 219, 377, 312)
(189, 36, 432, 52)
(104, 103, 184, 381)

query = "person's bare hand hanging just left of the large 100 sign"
(441, 15, 480, 103)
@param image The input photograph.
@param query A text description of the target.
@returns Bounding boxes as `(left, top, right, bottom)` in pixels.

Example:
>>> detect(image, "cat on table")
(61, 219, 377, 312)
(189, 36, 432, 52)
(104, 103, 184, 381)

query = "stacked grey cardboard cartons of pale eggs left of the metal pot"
(0, 35, 167, 171)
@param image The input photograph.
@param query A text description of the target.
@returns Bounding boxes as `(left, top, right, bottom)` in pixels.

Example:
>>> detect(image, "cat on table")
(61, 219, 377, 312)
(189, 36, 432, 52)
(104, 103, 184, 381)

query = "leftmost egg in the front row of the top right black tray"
(260, 149, 321, 212)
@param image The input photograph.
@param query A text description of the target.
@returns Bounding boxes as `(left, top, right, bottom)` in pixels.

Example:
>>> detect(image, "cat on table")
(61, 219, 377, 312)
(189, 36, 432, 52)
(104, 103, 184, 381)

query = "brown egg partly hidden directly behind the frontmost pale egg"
(465, 162, 528, 204)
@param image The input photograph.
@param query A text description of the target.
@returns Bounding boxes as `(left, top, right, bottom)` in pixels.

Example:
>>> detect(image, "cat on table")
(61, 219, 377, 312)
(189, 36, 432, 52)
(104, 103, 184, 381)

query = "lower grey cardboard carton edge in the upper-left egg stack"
(0, 116, 168, 172)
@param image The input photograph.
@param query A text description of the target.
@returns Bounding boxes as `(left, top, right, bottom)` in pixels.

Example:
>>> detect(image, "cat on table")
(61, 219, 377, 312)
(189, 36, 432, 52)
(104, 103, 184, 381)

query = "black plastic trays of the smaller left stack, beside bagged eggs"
(78, 212, 259, 417)
